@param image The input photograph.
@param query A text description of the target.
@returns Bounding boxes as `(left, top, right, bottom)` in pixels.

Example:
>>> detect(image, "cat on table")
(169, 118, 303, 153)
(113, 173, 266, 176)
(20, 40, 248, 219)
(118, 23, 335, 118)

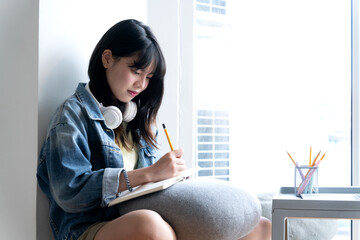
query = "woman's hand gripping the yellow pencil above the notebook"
(149, 149, 186, 182)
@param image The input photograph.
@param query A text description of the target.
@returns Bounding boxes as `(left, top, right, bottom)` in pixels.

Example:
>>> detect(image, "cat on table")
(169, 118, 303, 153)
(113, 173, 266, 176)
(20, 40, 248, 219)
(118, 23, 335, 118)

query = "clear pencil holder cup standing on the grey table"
(294, 165, 319, 196)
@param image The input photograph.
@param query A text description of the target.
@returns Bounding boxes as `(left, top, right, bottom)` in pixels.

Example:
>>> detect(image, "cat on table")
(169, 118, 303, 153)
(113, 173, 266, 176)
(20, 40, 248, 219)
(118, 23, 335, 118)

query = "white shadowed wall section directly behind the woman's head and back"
(36, 0, 147, 240)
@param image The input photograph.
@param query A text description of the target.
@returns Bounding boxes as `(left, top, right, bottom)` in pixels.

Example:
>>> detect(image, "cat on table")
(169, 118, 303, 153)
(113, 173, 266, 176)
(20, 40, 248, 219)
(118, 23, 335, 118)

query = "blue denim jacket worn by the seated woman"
(37, 83, 159, 240)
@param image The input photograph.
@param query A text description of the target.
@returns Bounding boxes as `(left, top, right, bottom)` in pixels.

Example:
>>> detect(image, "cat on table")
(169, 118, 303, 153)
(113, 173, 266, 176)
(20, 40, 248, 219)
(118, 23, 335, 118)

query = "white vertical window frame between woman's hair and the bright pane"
(147, 0, 195, 167)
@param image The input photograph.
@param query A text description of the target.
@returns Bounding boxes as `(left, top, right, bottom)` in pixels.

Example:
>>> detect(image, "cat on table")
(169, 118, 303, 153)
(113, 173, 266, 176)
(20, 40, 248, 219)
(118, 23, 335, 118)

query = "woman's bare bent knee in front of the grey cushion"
(94, 210, 176, 240)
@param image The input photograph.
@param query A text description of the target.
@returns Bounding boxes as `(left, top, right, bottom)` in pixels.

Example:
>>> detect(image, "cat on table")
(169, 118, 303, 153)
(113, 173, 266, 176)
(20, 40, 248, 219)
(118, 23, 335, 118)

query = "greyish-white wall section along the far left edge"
(0, 0, 39, 240)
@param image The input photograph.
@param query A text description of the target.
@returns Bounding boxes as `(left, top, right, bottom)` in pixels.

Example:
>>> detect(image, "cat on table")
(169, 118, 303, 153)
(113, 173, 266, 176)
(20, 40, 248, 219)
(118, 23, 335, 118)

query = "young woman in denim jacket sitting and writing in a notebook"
(37, 20, 270, 240)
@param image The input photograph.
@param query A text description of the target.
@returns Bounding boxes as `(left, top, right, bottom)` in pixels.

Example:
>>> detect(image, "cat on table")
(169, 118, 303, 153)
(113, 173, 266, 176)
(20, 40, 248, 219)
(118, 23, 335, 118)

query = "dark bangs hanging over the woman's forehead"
(130, 44, 165, 79)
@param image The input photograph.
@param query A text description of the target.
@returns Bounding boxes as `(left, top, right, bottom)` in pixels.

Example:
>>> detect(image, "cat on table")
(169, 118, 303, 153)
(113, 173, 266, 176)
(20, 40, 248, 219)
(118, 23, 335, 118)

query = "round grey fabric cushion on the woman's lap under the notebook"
(118, 179, 261, 240)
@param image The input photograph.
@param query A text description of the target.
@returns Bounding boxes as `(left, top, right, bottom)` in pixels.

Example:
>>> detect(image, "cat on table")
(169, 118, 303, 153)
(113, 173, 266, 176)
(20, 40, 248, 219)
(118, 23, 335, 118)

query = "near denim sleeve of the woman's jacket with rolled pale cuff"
(46, 121, 122, 212)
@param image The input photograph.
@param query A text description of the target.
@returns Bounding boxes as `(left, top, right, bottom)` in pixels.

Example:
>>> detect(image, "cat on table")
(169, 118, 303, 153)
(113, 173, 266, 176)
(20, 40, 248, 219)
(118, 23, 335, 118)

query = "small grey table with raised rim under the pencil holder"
(272, 187, 360, 240)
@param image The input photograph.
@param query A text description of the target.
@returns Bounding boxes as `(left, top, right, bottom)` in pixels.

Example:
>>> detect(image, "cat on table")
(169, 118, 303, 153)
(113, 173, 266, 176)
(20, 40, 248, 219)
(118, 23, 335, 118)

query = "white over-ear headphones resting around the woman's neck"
(85, 83, 137, 129)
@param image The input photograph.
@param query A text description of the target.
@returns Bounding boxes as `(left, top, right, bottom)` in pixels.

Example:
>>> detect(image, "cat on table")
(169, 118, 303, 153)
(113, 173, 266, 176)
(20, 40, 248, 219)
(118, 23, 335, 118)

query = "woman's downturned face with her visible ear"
(102, 50, 154, 103)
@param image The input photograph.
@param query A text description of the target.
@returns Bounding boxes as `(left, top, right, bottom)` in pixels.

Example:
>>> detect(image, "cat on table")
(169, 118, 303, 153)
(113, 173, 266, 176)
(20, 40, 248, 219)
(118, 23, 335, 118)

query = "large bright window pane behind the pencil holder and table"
(193, 0, 352, 239)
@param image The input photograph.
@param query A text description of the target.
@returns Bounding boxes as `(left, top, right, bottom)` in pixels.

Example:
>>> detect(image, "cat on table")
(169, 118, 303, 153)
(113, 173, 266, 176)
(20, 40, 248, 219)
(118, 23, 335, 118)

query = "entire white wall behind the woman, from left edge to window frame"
(0, 0, 186, 240)
